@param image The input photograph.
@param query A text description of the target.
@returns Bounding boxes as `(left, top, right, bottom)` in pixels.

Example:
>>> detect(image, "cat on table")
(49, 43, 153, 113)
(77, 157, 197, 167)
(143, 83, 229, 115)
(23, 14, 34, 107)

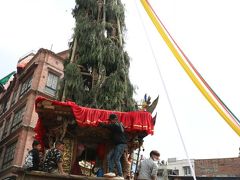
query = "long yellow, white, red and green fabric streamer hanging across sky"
(141, 0, 240, 136)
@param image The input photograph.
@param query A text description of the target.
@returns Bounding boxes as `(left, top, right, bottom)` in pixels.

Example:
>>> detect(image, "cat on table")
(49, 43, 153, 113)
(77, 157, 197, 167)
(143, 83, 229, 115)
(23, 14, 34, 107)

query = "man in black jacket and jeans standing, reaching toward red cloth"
(100, 114, 127, 177)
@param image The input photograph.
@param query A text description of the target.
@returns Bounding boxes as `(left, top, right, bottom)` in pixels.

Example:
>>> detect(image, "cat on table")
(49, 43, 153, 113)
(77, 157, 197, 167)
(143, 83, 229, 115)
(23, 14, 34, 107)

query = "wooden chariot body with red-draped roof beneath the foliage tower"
(35, 97, 158, 176)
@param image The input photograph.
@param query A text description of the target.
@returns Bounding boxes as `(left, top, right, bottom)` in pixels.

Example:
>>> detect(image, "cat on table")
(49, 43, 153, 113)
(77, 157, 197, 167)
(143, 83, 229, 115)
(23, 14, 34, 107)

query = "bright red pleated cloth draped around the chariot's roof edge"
(35, 97, 154, 143)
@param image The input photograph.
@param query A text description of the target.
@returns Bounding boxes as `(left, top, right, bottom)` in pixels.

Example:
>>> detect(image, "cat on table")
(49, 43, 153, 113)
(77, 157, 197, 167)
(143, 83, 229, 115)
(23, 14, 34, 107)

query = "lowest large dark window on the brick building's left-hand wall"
(2, 142, 17, 169)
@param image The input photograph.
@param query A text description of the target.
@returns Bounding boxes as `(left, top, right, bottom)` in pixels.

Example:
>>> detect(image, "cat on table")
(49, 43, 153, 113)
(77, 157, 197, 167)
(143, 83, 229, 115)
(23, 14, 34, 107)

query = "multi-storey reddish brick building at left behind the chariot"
(0, 49, 68, 178)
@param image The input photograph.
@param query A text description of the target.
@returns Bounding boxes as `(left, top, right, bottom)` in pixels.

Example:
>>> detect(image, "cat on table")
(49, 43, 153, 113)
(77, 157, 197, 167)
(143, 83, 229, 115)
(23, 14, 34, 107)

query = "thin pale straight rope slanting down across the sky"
(134, 1, 196, 180)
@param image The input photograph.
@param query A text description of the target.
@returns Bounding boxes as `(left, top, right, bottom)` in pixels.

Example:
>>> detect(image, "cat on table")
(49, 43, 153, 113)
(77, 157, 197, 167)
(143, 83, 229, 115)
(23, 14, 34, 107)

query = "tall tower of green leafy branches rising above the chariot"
(59, 0, 135, 111)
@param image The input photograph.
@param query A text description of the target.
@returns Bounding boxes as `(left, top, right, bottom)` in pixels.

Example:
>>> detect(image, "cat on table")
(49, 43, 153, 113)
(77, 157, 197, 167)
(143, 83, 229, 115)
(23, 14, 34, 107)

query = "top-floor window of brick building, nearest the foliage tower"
(45, 73, 59, 96)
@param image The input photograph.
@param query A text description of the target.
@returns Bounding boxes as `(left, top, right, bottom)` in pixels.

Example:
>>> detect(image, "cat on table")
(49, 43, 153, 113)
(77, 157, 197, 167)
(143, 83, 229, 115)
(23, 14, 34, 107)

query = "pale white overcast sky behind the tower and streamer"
(0, 0, 240, 160)
